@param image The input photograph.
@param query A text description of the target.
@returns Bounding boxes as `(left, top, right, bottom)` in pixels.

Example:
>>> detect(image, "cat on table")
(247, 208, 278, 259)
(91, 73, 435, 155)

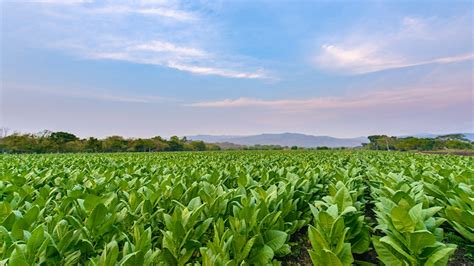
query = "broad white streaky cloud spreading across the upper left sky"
(11, 0, 270, 79)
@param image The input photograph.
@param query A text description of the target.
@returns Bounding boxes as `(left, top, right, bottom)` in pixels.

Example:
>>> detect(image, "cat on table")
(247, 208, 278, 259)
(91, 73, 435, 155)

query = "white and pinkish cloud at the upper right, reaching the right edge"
(314, 17, 474, 74)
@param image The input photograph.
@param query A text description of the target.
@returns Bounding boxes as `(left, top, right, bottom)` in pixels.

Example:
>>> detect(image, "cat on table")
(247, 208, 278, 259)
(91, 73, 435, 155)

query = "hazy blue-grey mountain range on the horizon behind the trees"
(186, 133, 474, 148)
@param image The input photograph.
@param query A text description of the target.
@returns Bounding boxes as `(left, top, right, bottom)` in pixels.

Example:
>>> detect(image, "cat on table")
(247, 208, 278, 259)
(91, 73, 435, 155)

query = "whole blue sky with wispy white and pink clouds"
(0, 0, 474, 137)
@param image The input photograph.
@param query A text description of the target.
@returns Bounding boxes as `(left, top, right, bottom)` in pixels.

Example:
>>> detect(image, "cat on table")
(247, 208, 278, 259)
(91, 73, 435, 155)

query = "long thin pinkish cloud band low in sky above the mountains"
(186, 87, 472, 112)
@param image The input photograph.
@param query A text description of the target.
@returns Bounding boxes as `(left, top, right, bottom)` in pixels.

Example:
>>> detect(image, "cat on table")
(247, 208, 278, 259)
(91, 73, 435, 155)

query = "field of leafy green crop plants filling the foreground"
(0, 151, 474, 265)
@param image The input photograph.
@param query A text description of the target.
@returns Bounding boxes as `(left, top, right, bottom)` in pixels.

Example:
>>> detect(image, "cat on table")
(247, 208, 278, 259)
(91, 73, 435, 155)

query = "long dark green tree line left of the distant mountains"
(0, 131, 220, 153)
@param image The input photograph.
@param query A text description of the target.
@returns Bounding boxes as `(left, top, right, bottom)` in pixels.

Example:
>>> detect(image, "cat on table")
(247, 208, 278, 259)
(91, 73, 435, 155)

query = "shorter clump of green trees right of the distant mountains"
(364, 134, 474, 151)
